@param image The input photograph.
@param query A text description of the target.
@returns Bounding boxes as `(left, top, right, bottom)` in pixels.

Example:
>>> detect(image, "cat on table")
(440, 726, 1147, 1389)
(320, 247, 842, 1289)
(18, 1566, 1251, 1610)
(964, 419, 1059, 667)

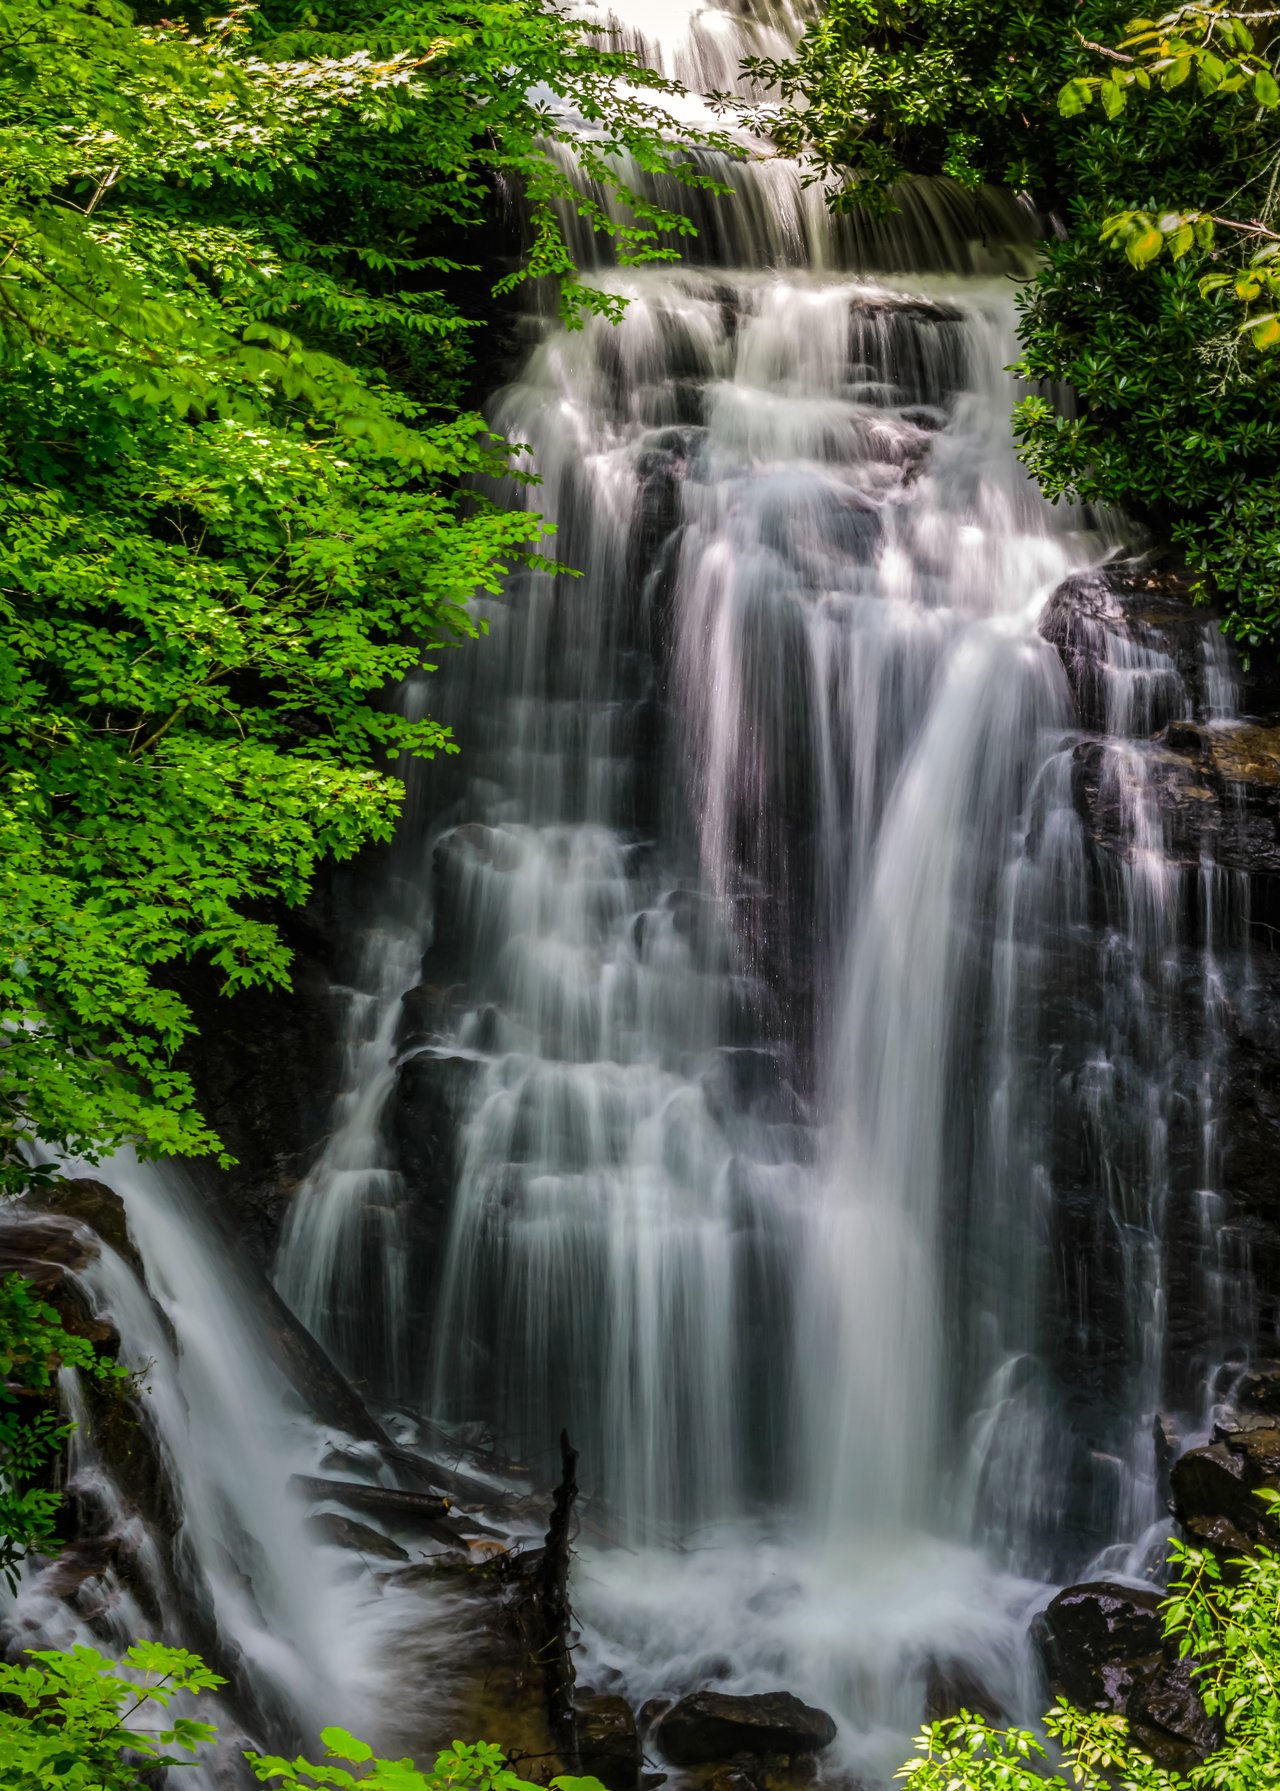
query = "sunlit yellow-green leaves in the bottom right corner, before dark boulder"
(899, 1494, 1280, 1791)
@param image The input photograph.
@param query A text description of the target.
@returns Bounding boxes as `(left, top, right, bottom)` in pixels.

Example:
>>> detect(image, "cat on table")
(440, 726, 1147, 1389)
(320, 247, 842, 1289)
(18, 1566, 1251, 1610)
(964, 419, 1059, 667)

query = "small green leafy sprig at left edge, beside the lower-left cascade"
(0, 1275, 125, 1590)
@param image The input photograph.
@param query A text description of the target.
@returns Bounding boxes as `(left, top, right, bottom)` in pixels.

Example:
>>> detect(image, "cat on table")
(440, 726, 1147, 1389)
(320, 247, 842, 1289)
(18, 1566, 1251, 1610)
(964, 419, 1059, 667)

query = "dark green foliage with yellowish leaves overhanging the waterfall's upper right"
(761, 0, 1280, 647)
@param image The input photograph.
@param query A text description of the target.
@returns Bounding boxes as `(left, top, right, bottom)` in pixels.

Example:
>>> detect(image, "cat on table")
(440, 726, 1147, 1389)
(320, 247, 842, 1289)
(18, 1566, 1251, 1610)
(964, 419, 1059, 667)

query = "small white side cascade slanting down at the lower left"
(4, 1157, 474, 1791)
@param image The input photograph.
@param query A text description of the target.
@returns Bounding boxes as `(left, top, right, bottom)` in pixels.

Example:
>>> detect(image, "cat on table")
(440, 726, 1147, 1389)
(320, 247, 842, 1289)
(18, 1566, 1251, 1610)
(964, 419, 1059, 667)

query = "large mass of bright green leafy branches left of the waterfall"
(0, 0, 719, 1191)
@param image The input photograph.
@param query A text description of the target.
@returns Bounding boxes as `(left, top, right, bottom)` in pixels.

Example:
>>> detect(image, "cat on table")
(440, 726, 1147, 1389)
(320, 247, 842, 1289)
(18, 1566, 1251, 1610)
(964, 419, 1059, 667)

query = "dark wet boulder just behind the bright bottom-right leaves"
(1035, 1581, 1221, 1771)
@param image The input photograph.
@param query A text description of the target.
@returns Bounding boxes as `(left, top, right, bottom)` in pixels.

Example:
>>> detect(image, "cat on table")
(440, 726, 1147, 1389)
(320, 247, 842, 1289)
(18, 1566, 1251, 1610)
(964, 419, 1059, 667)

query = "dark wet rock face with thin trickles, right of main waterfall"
(1024, 559, 1280, 1454)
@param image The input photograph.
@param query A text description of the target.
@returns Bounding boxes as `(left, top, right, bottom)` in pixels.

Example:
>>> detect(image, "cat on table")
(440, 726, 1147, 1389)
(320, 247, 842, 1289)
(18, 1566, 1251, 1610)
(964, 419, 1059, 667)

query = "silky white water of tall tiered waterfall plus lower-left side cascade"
(0, 5, 1248, 1773)
